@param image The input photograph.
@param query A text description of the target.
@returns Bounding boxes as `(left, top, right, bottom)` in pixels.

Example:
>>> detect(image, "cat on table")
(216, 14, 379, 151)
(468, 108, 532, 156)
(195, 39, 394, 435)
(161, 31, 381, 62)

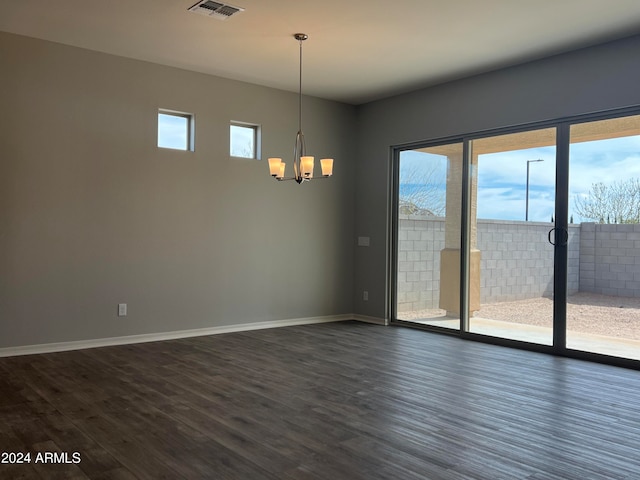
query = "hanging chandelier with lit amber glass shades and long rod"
(269, 33, 333, 183)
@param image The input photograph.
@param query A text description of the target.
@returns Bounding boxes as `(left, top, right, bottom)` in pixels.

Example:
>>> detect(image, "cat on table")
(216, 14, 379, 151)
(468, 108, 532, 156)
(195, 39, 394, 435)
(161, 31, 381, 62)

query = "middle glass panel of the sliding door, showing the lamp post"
(468, 128, 556, 345)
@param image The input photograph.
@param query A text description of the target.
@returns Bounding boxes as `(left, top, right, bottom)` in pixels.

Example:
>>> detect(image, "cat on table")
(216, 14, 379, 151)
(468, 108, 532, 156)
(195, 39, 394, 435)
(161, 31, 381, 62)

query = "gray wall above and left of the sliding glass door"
(354, 36, 640, 318)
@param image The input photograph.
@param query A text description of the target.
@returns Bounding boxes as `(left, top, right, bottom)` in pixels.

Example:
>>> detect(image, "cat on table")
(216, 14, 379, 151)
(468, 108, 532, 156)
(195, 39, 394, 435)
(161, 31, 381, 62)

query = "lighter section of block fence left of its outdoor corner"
(397, 215, 580, 312)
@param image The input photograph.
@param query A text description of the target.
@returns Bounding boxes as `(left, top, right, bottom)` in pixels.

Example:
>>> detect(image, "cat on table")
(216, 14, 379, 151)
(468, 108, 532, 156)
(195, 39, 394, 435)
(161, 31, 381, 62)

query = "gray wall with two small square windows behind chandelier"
(0, 33, 356, 347)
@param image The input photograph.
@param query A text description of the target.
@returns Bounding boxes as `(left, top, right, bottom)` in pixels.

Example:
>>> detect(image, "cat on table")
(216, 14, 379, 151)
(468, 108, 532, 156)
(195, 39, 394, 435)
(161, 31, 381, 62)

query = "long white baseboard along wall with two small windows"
(0, 315, 356, 357)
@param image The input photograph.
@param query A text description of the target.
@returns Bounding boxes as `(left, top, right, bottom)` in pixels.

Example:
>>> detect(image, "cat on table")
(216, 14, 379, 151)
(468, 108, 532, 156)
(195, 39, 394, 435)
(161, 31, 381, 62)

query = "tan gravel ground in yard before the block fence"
(399, 292, 640, 340)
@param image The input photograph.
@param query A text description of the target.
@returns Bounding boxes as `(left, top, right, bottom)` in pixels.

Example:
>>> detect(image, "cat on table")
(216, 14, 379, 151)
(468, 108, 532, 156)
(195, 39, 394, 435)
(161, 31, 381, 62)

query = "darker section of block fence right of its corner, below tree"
(580, 223, 640, 297)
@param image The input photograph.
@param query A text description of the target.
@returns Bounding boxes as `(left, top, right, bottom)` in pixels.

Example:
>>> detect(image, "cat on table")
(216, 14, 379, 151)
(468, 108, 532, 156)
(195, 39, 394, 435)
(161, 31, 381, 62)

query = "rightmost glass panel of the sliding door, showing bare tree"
(567, 115, 640, 360)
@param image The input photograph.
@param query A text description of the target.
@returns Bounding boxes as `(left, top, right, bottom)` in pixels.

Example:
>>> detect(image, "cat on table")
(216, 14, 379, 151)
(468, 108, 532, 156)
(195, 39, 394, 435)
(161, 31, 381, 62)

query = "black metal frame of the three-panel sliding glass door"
(388, 105, 640, 370)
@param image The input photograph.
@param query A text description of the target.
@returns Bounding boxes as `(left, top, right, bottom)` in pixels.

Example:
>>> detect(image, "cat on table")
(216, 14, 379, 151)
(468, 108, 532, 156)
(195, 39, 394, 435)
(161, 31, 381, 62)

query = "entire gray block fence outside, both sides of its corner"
(397, 215, 640, 312)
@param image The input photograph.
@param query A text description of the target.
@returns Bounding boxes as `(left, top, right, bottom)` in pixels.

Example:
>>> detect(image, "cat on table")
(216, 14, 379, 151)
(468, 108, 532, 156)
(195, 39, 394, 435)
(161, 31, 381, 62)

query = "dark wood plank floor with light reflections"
(0, 322, 640, 480)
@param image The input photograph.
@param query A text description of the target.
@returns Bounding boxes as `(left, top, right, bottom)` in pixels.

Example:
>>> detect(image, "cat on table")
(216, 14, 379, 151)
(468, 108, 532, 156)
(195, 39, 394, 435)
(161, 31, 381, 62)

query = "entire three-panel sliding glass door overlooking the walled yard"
(393, 109, 640, 360)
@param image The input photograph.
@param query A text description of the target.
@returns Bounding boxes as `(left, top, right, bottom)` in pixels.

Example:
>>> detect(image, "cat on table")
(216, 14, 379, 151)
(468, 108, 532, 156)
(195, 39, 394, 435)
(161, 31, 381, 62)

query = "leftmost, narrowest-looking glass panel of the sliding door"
(395, 143, 463, 329)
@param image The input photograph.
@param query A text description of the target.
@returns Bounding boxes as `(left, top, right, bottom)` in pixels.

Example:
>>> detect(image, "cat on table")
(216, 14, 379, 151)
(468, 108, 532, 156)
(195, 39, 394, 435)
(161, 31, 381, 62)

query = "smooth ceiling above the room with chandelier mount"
(0, 0, 640, 105)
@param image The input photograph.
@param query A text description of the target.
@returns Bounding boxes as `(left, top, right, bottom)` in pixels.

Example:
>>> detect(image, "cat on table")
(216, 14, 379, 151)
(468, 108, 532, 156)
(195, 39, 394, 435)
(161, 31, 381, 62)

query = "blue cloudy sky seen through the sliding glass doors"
(400, 136, 640, 223)
